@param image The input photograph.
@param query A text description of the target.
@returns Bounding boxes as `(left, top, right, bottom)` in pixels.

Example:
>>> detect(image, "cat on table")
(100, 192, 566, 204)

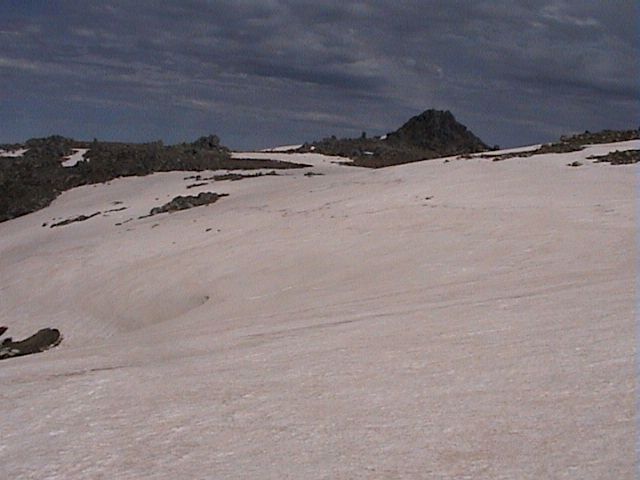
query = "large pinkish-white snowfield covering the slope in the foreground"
(0, 141, 640, 480)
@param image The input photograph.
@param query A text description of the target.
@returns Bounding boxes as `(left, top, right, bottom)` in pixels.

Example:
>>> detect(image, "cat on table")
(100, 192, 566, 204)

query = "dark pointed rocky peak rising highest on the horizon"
(387, 110, 489, 154)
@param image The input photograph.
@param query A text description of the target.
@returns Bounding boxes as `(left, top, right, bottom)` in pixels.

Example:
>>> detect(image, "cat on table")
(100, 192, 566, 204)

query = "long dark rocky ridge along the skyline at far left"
(0, 135, 306, 222)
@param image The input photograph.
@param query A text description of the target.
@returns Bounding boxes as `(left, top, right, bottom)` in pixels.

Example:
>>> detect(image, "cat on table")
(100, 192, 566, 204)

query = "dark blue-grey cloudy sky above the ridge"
(0, 0, 640, 149)
